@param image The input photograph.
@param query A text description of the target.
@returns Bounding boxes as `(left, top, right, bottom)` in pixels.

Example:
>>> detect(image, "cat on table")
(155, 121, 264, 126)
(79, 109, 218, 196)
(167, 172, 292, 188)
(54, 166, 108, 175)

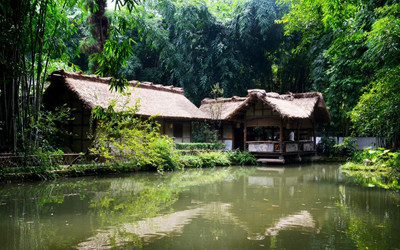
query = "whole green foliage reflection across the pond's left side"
(0, 168, 253, 249)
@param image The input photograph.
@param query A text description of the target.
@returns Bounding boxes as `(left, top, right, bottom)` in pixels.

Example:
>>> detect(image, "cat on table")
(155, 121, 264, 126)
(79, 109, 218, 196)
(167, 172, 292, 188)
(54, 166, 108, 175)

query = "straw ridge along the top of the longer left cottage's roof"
(48, 69, 183, 95)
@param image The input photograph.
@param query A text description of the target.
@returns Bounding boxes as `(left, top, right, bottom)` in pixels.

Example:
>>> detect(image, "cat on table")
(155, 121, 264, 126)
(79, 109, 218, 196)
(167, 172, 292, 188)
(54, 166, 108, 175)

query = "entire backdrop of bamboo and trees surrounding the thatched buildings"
(0, 0, 400, 158)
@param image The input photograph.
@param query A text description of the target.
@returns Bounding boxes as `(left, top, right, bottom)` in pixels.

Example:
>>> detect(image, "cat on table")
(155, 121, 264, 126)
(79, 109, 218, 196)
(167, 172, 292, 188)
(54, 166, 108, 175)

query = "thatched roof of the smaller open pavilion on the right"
(200, 89, 330, 123)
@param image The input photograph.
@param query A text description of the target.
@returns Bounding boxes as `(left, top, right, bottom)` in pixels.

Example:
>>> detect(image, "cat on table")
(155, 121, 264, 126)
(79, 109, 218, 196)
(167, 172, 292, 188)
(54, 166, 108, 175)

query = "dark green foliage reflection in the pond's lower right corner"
(338, 186, 400, 249)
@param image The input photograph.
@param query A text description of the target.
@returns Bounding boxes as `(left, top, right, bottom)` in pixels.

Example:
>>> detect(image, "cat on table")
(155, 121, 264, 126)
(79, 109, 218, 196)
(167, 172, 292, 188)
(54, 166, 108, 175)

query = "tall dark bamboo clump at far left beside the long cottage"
(0, 0, 79, 152)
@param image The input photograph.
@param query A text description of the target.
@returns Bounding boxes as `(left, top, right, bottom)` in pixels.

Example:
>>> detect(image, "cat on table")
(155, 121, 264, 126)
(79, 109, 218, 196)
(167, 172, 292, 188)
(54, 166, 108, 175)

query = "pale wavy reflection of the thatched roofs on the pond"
(77, 202, 318, 249)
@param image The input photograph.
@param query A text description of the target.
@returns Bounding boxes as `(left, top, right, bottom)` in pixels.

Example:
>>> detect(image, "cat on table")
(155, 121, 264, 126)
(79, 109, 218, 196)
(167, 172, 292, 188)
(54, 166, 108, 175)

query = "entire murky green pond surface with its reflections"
(0, 164, 400, 249)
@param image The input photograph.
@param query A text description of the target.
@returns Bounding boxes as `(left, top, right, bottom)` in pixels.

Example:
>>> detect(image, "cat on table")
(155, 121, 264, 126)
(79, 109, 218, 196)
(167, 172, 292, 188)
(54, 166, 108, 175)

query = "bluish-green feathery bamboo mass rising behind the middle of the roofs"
(112, 0, 283, 104)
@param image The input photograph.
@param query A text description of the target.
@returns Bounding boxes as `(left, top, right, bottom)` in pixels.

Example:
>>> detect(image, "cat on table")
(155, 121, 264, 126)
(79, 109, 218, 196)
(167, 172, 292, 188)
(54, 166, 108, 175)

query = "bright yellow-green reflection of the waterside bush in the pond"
(90, 169, 250, 225)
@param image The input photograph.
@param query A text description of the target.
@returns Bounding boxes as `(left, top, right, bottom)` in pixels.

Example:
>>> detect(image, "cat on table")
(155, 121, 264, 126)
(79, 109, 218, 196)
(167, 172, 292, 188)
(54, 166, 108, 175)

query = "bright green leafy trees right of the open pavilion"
(281, 0, 400, 147)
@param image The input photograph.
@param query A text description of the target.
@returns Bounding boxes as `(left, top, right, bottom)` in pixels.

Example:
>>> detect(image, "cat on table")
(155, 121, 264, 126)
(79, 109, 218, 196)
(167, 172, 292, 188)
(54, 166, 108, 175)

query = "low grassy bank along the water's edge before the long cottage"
(0, 151, 256, 182)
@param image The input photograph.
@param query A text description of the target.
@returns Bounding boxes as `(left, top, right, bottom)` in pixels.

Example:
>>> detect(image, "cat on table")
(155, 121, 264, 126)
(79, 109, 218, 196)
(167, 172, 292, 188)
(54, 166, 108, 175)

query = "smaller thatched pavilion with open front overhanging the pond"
(200, 89, 330, 162)
